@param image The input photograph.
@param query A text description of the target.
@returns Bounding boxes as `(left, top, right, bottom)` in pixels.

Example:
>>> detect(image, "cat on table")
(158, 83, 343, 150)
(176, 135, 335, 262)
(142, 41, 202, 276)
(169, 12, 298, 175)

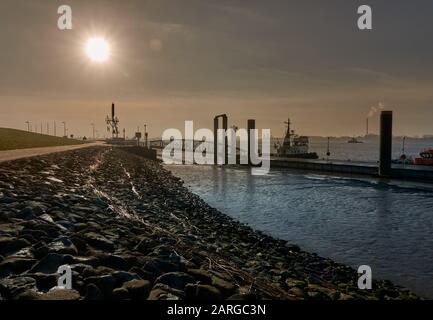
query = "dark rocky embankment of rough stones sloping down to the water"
(0, 147, 417, 300)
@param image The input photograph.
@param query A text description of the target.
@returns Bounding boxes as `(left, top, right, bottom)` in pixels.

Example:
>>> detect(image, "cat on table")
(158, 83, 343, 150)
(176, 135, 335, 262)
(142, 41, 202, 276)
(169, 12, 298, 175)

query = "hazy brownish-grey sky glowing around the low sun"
(0, 0, 433, 136)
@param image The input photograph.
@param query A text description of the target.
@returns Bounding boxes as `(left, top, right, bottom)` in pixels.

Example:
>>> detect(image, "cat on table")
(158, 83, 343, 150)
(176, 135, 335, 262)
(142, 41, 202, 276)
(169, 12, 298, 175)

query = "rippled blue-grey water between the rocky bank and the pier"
(168, 166, 433, 298)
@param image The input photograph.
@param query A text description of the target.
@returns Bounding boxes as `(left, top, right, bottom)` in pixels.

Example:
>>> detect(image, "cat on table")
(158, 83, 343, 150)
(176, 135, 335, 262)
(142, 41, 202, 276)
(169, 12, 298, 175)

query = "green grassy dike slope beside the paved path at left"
(0, 128, 84, 151)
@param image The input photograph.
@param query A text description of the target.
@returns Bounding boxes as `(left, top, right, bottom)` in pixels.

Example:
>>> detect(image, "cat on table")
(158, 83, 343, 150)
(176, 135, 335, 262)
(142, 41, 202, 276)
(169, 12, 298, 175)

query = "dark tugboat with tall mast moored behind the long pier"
(275, 119, 319, 159)
